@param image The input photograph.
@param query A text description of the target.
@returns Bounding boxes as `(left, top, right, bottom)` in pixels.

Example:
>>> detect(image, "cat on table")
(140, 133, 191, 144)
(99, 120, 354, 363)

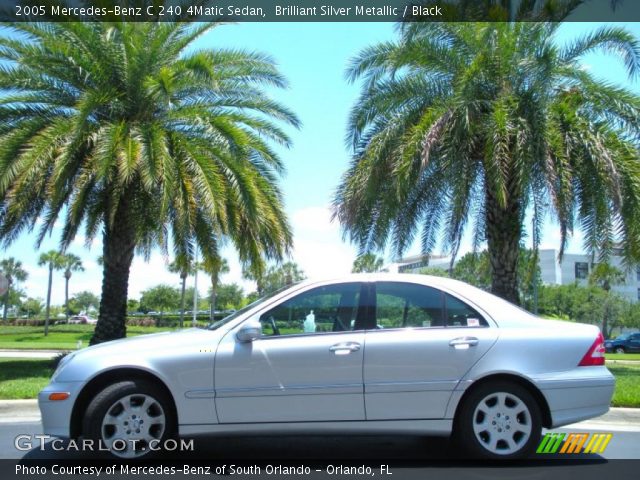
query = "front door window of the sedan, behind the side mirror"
(260, 283, 361, 336)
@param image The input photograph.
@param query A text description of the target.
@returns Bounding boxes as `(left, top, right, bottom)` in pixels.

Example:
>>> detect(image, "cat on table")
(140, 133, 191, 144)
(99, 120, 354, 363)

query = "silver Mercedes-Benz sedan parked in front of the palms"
(39, 274, 614, 458)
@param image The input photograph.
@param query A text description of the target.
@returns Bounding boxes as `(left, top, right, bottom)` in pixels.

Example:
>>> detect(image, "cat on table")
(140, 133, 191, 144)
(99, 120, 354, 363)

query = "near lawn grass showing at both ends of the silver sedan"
(0, 358, 640, 408)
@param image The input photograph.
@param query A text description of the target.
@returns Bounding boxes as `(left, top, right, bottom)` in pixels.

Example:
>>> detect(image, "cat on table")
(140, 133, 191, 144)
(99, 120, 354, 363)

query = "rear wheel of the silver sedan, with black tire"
(453, 381, 542, 460)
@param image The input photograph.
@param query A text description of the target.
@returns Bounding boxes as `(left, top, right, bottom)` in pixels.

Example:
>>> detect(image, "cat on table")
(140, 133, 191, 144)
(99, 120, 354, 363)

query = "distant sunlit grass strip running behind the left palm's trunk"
(0, 325, 175, 350)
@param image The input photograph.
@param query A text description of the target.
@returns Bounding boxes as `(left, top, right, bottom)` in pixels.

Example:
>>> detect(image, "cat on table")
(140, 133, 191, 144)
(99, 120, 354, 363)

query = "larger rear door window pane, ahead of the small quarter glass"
(376, 282, 444, 328)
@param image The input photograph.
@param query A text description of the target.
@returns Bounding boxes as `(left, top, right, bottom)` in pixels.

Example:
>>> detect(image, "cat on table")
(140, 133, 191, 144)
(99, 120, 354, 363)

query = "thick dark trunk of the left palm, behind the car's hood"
(89, 199, 136, 345)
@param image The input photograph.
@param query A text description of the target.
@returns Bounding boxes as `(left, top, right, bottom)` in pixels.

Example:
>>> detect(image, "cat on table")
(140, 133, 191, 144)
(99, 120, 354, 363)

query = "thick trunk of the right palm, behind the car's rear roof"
(486, 187, 522, 305)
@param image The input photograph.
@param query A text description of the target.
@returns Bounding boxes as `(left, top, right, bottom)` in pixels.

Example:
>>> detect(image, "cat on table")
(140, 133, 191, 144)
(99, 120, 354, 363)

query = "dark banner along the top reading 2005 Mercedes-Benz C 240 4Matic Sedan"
(0, 0, 640, 22)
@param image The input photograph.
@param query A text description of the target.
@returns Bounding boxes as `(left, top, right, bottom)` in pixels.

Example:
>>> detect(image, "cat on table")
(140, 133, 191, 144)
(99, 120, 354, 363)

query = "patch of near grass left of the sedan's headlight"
(0, 358, 53, 400)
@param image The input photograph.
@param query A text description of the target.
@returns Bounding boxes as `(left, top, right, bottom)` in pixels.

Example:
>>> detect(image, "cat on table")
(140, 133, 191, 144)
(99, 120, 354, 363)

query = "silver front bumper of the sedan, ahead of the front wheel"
(38, 382, 84, 438)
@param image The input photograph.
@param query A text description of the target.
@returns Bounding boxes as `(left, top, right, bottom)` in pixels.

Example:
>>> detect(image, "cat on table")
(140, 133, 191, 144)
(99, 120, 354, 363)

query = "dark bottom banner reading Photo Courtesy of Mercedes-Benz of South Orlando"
(0, 460, 640, 480)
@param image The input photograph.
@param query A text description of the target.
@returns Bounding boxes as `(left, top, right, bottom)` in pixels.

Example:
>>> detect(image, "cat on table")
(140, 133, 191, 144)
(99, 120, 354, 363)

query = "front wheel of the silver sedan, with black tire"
(82, 379, 176, 459)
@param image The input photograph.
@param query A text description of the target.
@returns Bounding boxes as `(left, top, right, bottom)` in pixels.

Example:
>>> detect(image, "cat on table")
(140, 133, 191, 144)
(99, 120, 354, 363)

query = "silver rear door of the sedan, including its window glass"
(364, 282, 498, 420)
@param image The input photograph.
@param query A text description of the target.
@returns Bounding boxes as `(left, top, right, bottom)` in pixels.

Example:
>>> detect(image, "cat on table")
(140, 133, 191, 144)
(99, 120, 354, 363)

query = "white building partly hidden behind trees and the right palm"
(385, 249, 640, 302)
